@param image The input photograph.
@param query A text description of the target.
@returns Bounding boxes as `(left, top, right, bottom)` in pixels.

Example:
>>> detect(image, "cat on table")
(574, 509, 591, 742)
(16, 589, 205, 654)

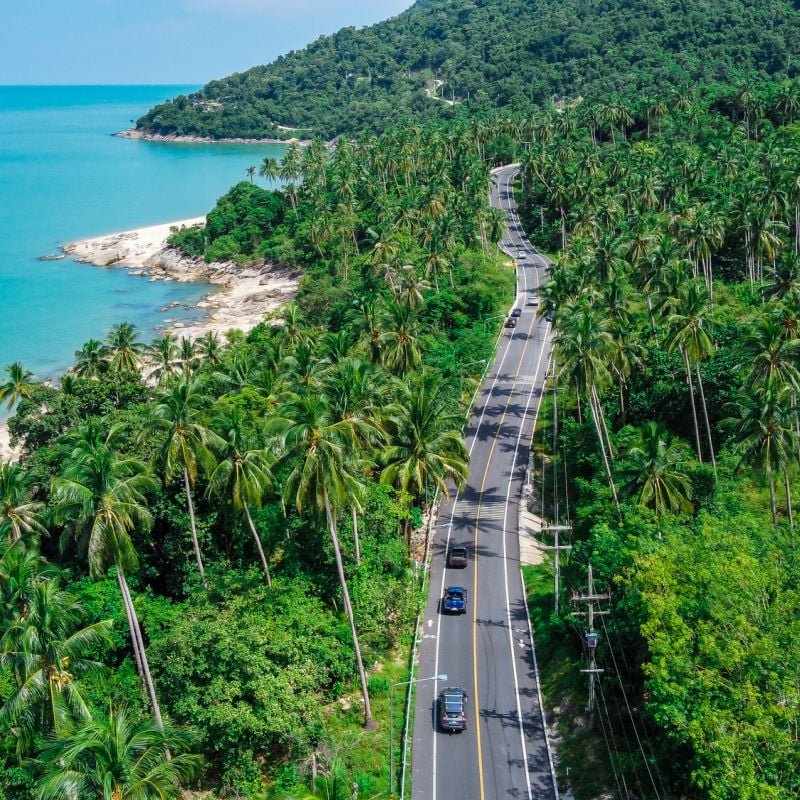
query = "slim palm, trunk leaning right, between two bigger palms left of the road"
(206, 407, 273, 586)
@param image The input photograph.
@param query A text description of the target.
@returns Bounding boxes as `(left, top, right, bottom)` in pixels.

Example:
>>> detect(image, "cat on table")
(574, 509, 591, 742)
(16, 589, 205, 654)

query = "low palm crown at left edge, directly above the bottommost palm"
(0, 580, 111, 753)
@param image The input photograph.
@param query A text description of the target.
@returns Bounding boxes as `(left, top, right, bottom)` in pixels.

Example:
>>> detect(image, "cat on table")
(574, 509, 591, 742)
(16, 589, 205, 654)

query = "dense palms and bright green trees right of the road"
(520, 78, 800, 800)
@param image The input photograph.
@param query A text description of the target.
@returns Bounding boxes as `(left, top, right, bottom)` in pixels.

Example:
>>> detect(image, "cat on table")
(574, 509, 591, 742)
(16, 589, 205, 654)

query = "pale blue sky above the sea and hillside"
(0, 0, 412, 84)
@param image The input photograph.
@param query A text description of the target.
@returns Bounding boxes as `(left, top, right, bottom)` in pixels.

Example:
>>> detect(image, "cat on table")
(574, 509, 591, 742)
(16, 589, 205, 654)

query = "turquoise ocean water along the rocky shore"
(0, 86, 283, 379)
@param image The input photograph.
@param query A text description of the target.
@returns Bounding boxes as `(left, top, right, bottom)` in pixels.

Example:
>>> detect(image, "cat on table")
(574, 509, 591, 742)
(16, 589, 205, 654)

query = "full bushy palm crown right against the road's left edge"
(381, 370, 469, 500)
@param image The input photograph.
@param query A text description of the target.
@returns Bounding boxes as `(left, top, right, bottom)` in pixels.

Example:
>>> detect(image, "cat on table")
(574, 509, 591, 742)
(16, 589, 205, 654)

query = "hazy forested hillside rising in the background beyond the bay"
(137, 0, 800, 139)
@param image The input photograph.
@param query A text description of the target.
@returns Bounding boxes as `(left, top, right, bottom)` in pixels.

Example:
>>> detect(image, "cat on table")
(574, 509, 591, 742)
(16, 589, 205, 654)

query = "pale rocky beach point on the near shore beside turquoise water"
(63, 217, 300, 339)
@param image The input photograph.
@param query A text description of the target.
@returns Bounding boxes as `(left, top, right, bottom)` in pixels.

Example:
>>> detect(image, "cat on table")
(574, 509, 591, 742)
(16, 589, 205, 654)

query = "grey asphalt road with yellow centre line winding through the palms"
(412, 167, 558, 800)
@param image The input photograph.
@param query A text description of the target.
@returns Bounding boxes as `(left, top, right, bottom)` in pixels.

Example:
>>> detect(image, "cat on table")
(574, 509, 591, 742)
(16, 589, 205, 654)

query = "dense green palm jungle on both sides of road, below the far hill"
(0, 3, 800, 800)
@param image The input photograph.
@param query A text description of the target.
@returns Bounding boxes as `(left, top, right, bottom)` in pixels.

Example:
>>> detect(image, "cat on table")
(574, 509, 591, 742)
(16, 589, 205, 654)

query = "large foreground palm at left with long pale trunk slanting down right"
(52, 419, 161, 725)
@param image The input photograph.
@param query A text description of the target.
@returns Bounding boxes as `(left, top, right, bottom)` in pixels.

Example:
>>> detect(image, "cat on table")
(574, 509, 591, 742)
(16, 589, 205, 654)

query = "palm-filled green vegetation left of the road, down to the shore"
(0, 122, 514, 800)
